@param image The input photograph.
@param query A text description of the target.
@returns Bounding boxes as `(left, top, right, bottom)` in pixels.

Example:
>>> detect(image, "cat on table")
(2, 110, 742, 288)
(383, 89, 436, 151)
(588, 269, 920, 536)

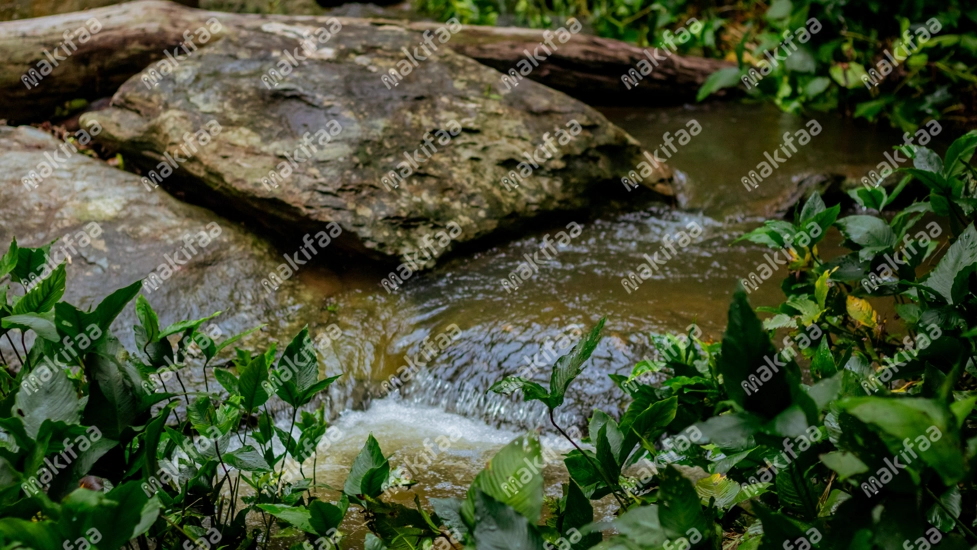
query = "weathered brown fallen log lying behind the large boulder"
(0, 0, 730, 123)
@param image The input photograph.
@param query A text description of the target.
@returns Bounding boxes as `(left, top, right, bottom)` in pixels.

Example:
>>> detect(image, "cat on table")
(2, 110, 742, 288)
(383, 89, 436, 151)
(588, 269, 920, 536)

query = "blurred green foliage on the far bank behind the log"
(416, 0, 977, 131)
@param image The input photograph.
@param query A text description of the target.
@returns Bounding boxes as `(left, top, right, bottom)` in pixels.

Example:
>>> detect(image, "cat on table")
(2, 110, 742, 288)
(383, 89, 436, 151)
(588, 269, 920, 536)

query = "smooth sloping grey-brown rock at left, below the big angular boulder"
(0, 126, 330, 382)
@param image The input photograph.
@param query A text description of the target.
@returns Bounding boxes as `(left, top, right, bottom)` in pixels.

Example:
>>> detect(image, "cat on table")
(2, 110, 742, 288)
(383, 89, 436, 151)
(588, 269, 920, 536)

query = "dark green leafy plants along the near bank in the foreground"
(0, 132, 977, 550)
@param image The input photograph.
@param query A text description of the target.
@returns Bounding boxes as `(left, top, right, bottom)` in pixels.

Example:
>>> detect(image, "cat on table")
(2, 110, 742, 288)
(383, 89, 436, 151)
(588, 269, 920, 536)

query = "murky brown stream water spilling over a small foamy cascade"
(270, 104, 920, 548)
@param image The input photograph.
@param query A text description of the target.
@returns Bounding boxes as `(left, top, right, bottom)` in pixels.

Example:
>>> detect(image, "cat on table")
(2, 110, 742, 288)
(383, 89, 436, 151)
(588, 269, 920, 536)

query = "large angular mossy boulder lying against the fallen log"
(82, 18, 670, 266)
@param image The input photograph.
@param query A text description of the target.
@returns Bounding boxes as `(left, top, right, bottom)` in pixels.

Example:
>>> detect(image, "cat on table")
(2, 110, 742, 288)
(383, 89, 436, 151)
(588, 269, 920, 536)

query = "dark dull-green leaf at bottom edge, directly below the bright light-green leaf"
(470, 487, 543, 550)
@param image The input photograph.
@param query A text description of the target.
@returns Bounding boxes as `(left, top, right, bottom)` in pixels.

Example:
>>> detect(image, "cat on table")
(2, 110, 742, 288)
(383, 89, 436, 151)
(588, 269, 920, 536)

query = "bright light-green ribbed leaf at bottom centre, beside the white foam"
(466, 436, 543, 524)
